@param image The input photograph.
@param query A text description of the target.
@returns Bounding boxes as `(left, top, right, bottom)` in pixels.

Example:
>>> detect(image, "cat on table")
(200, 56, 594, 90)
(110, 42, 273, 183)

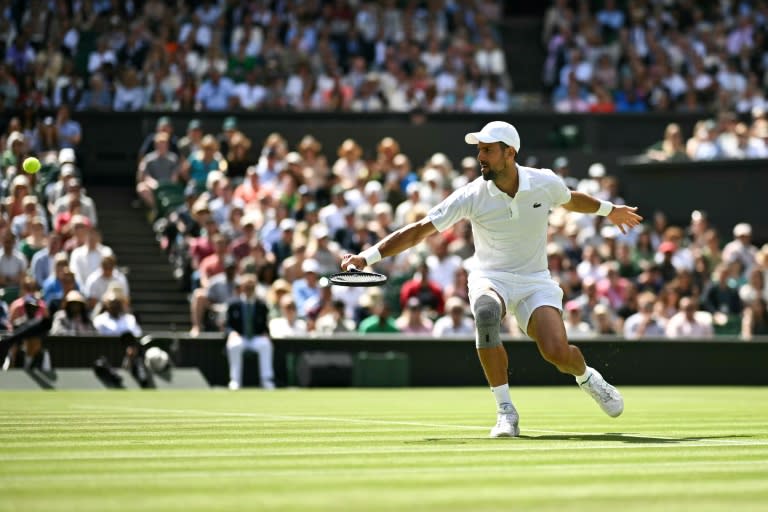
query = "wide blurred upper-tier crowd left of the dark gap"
(0, 0, 509, 112)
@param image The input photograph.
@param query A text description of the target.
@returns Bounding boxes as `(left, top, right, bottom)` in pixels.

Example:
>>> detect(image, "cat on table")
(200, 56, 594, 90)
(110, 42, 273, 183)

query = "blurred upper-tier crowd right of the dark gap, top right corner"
(542, 0, 768, 113)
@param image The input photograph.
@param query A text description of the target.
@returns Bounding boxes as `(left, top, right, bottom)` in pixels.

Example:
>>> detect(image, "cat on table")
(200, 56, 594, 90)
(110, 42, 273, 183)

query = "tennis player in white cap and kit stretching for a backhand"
(341, 121, 643, 437)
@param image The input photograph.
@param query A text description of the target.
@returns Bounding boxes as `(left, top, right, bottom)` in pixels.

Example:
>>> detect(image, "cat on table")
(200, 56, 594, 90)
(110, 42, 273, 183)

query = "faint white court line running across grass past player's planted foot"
(72, 405, 768, 446)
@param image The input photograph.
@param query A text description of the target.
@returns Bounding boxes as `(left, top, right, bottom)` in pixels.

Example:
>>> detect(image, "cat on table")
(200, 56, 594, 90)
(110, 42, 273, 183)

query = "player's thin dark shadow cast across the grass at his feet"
(406, 432, 754, 444)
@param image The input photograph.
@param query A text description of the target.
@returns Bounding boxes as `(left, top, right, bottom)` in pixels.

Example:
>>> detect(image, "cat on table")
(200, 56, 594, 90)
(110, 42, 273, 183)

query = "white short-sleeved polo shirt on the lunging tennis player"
(427, 165, 571, 274)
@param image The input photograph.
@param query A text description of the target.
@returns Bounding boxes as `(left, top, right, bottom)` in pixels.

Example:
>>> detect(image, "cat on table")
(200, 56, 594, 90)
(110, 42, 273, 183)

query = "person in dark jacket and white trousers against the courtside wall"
(226, 274, 275, 390)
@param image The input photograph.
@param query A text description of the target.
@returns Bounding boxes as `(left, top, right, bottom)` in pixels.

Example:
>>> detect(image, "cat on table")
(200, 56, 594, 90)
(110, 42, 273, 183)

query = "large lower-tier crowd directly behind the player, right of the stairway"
(137, 118, 768, 352)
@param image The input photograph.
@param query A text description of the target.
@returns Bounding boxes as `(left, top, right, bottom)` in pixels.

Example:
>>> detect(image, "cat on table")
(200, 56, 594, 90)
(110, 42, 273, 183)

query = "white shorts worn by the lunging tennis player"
(468, 270, 563, 335)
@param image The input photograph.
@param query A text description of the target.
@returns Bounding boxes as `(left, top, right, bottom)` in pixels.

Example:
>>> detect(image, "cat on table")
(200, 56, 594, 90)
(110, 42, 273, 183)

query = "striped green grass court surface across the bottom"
(0, 386, 768, 512)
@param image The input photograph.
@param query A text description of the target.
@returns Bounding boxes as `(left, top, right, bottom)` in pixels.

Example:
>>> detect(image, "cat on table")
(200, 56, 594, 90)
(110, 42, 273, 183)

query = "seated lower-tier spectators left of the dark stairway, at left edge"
(0, 105, 142, 368)
